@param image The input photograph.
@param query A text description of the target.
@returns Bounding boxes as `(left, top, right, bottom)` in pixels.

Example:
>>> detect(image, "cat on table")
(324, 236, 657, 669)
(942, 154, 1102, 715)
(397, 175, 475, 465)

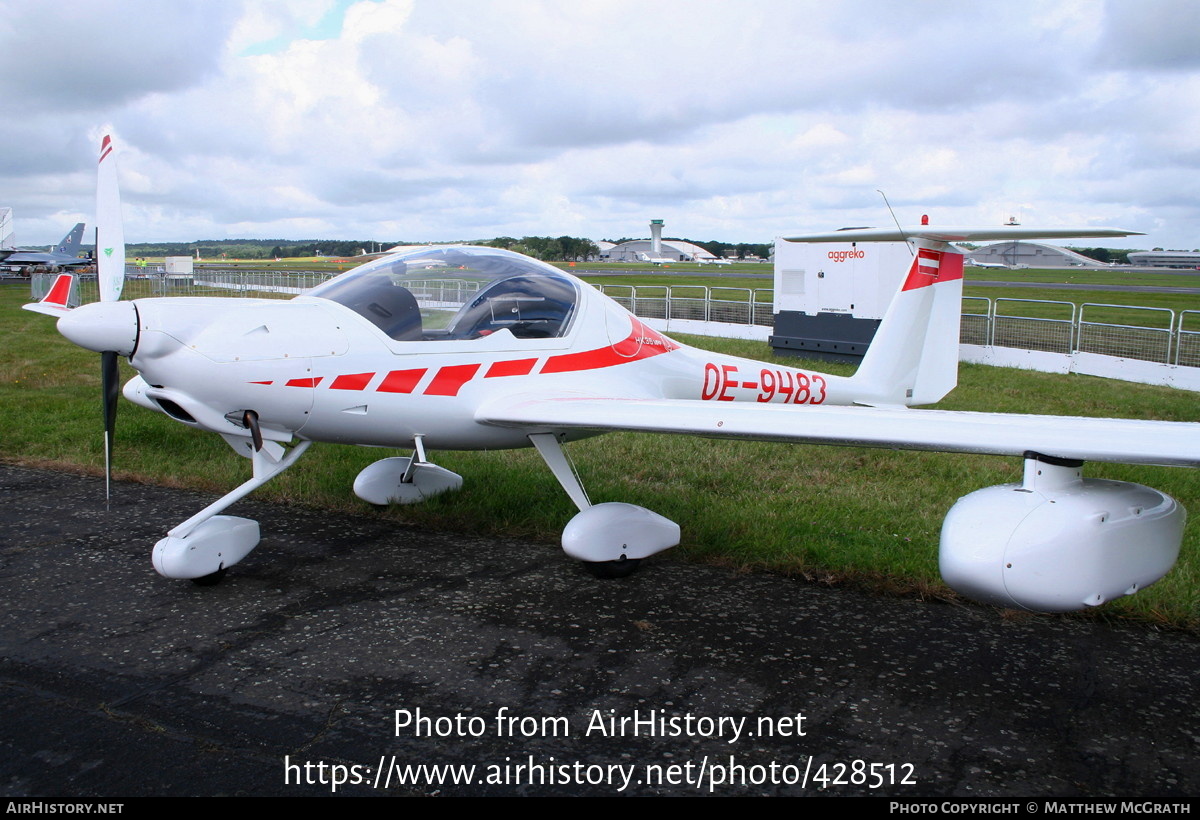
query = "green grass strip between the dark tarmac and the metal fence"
(0, 286, 1200, 629)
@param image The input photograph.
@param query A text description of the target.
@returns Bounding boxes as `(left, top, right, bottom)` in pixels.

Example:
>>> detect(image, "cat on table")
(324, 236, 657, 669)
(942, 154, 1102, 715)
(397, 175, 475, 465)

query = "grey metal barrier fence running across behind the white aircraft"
(31, 269, 1200, 367)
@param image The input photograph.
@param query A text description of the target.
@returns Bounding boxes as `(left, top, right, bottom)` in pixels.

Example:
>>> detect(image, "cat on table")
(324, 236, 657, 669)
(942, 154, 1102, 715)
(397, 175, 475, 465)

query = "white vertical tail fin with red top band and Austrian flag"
(852, 240, 962, 406)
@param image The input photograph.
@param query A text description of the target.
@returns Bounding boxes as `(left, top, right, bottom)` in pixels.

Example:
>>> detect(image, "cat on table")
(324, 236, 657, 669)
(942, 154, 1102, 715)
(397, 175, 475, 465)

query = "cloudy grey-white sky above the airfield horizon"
(0, 0, 1200, 249)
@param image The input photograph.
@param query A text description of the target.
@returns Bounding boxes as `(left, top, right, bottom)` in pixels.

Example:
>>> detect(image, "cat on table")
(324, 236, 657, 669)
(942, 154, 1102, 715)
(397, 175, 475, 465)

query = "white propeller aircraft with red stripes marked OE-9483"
(26, 139, 1200, 611)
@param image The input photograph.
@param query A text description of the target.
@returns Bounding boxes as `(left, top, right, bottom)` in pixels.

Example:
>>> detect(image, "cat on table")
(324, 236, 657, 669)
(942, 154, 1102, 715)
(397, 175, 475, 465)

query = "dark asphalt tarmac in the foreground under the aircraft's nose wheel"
(0, 466, 1200, 797)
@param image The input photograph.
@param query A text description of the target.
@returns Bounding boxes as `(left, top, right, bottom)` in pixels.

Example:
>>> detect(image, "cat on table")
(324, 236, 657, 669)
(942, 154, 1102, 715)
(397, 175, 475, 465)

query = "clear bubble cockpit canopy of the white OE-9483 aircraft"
(308, 246, 580, 342)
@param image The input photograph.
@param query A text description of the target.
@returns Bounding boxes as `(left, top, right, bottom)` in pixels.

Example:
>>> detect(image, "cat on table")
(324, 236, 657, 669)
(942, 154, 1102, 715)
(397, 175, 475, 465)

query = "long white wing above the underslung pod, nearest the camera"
(475, 395, 1200, 467)
